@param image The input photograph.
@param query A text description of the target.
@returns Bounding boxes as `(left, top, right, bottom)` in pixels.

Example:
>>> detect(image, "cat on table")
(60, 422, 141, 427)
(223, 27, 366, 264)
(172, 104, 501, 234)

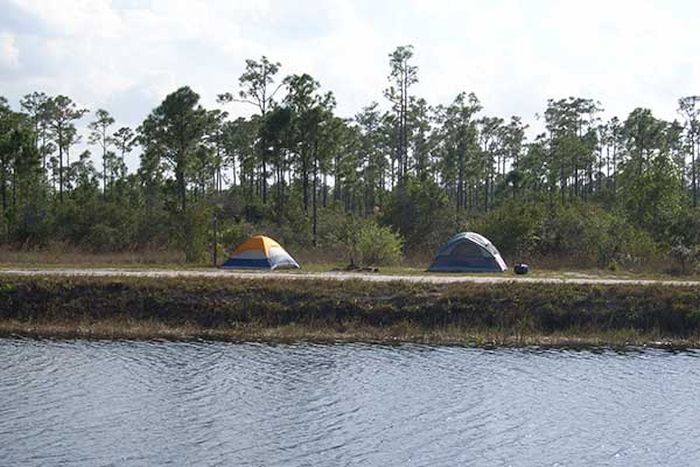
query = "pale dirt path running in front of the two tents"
(0, 268, 700, 287)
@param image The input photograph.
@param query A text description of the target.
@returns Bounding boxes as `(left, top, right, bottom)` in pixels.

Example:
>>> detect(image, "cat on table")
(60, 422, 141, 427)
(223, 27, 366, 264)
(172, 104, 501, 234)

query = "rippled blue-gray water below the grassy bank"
(0, 339, 700, 466)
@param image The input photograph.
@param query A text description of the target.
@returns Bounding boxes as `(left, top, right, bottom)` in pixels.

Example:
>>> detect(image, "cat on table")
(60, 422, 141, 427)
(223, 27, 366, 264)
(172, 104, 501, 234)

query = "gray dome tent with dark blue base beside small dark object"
(428, 232, 508, 272)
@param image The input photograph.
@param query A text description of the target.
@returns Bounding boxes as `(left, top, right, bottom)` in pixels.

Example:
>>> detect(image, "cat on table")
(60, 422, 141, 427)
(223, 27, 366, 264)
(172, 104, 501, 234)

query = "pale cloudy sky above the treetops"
(0, 0, 700, 167)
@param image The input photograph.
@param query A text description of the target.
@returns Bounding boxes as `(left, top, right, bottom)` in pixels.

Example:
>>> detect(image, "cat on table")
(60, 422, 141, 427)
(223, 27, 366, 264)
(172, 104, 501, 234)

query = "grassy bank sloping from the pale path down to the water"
(0, 276, 700, 346)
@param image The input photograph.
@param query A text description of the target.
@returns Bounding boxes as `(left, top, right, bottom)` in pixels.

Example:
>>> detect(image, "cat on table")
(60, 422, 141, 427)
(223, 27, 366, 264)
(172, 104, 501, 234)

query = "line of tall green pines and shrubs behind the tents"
(0, 46, 700, 268)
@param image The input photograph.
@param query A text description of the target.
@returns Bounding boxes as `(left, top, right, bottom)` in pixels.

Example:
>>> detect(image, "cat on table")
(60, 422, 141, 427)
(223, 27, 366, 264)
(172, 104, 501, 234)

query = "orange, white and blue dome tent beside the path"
(221, 235, 300, 270)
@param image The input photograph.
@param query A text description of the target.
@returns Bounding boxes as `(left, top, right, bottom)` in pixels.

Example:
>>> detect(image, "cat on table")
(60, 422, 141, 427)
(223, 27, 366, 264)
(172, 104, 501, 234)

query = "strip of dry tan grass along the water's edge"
(0, 320, 688, 348)
